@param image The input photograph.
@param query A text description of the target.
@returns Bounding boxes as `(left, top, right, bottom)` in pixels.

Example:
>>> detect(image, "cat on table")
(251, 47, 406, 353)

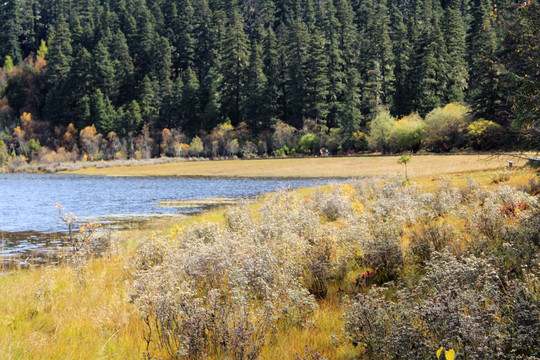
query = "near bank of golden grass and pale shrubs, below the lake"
(0, 167, 540, 360)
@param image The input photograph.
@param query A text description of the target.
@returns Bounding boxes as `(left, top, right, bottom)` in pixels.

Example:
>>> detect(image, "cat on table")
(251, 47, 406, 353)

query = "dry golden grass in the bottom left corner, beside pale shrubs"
(0, 258, 143, 359)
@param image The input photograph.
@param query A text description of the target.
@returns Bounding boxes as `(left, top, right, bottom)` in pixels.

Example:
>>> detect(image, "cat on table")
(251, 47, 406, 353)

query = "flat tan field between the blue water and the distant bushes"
(64, 155, 525, 177)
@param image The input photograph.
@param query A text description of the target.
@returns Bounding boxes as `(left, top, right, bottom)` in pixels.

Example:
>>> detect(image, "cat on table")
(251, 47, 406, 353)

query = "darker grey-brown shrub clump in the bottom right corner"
(344, 253, 540, 359)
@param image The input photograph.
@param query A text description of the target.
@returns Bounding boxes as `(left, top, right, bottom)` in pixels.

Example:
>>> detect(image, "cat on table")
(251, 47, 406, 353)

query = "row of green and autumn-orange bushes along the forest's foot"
(0, 103, 524, 171)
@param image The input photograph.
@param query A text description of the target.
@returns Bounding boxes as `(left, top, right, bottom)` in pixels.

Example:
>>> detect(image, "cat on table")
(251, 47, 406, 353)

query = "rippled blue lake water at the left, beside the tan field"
(0, 174, 343, 262)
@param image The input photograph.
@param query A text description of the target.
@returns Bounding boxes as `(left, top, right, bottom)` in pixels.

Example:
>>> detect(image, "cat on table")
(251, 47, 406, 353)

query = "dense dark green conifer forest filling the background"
(0, 0, 540, 162)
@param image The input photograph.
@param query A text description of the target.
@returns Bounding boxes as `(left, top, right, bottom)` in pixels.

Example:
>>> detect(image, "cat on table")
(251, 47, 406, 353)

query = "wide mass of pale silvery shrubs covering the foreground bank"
(129, 181, 540, 359)
